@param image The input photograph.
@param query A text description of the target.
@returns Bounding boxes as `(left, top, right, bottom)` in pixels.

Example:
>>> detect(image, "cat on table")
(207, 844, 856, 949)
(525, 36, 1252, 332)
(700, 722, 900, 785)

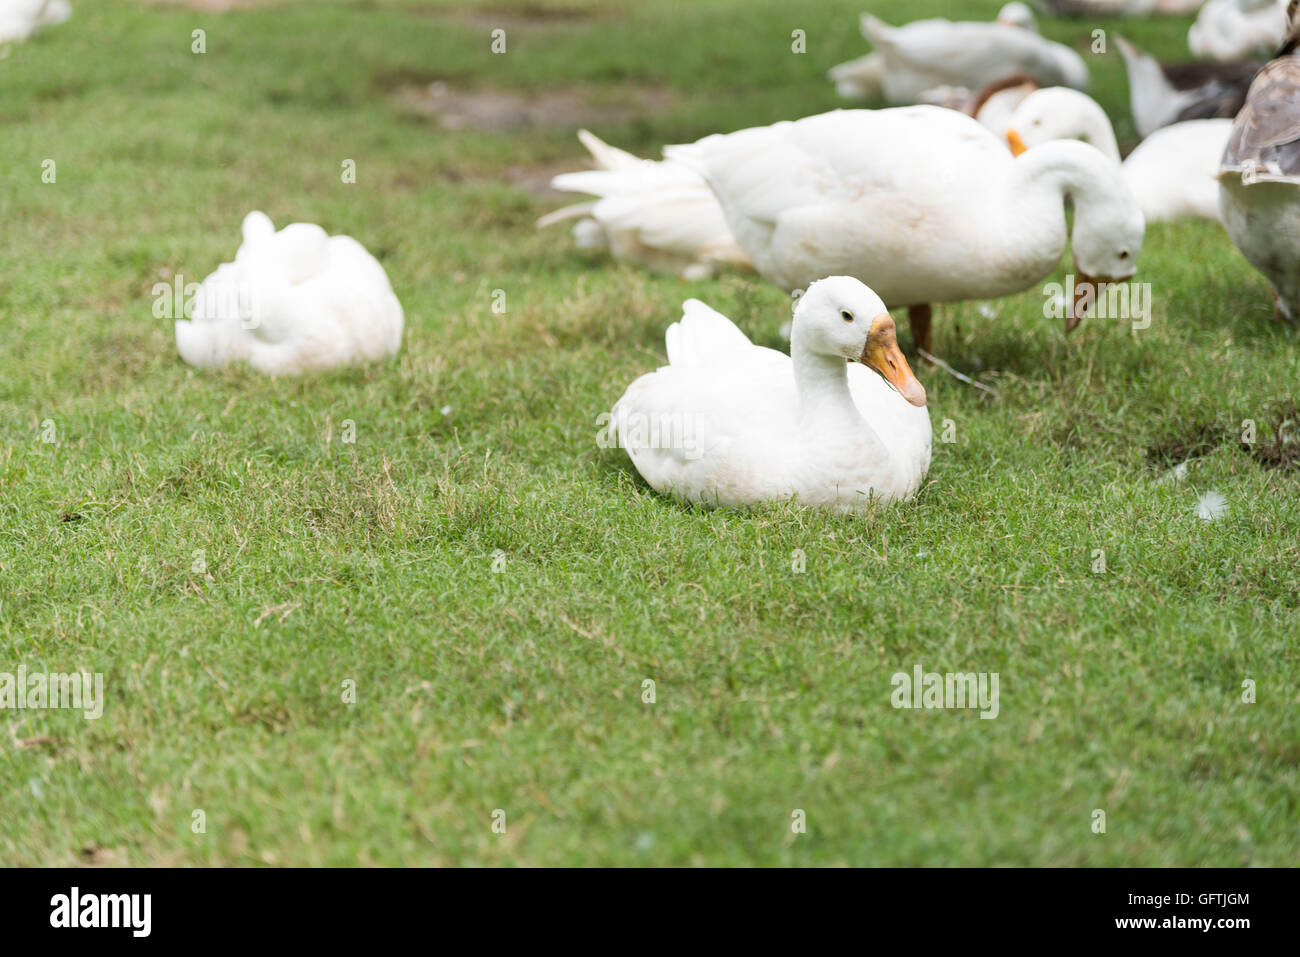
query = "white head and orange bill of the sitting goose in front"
(790, 276, 926, 406)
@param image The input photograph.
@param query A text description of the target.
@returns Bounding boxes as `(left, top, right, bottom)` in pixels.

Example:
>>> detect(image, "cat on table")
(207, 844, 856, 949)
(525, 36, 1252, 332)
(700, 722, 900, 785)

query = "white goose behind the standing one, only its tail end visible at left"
(537, 130, 749, 280)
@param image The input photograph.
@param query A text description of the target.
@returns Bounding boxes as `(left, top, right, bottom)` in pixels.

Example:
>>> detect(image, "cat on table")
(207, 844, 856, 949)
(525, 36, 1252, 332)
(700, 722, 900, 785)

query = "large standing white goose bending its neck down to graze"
(666, 107, 1145, 352)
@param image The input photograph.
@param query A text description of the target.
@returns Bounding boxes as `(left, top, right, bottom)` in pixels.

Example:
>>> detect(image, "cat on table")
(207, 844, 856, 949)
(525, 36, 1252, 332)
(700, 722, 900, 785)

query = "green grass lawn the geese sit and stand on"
(0, 0, 1300, 865)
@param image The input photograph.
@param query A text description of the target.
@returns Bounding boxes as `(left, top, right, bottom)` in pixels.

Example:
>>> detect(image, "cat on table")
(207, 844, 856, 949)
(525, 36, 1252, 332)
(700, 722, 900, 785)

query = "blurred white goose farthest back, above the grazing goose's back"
(828, 3, 1088, 104)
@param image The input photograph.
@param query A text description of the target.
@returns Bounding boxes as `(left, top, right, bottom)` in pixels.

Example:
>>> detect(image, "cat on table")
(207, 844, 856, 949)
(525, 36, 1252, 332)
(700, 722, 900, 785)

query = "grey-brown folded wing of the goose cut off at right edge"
(1223, 56, 1300, 182)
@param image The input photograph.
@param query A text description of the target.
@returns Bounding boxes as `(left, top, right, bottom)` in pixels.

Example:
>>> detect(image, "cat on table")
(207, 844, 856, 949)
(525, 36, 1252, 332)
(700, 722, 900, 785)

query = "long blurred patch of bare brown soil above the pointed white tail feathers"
(395, 81, 673, 133)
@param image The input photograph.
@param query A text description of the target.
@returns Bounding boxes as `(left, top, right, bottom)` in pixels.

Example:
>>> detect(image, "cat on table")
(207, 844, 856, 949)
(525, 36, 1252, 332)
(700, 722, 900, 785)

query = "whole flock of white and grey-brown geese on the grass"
(15, 0, 1300, 511)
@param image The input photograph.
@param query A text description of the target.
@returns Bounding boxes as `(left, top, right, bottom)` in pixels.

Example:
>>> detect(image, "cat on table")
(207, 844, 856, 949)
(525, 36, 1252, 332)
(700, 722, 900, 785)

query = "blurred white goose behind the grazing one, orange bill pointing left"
(1006, 87, 1232, 222)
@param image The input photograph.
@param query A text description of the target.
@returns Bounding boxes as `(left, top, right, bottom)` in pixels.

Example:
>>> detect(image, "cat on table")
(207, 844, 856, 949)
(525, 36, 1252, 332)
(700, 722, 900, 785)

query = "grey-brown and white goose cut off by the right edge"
(1219, 53, 1300, 321)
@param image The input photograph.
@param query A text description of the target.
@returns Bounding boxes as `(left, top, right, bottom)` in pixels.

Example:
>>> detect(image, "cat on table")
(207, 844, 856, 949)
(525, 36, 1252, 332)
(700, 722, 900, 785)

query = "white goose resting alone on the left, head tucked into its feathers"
(176, 211, 403, 374)
